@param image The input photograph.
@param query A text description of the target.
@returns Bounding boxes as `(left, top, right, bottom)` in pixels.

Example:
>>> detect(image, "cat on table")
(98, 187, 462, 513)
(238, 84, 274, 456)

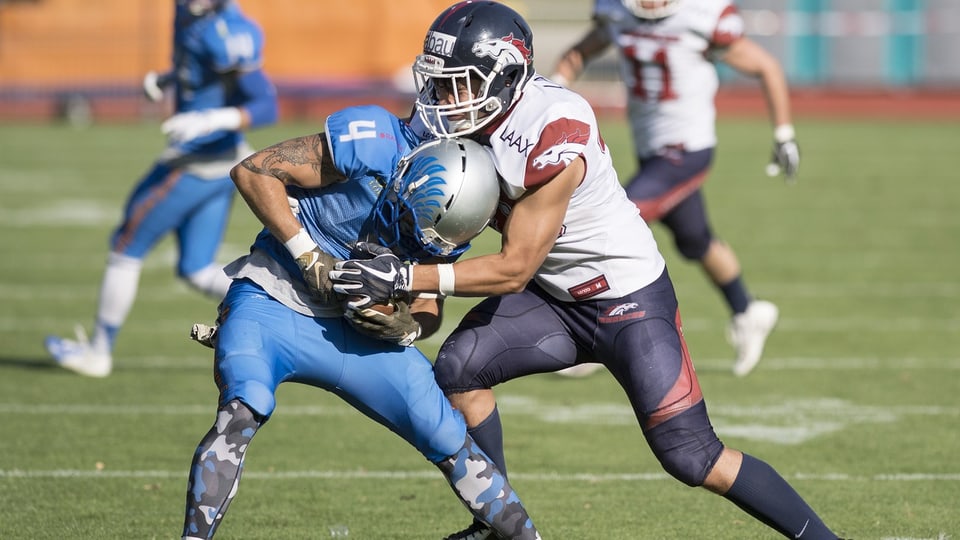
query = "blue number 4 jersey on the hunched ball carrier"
(253, 105, 420, 279)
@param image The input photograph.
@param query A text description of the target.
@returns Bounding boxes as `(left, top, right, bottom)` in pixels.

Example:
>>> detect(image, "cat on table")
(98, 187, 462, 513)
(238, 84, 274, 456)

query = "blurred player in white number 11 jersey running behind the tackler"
(552, 0, 800, 377)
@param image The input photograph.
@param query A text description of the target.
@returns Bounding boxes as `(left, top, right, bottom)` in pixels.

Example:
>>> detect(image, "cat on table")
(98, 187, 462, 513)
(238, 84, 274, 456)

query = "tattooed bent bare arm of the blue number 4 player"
(230, 133, 343, 246)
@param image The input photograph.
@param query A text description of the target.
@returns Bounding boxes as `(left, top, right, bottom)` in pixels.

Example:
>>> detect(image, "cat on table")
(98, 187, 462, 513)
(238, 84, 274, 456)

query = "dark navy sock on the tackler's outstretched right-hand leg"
(724, 454, 837, 540)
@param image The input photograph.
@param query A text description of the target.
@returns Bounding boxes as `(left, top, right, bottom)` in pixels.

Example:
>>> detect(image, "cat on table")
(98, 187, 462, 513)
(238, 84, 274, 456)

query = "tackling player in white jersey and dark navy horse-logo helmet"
(330, 1, 836, 540)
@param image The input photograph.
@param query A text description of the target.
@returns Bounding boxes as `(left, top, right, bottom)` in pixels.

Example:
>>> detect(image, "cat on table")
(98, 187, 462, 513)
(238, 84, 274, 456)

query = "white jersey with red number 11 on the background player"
(593, 0, 743, 157)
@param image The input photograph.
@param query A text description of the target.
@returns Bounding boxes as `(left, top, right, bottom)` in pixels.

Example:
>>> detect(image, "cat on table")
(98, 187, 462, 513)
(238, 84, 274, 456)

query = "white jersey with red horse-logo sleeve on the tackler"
(413, 75, 665, 301)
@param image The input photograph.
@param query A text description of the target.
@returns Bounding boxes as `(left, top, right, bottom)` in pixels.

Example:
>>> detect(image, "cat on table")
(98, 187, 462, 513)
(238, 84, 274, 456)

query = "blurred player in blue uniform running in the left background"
(45, 0, 277, 377)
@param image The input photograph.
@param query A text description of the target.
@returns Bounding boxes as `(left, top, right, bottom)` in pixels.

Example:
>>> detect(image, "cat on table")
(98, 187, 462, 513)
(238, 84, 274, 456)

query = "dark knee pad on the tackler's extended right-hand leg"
(644, 400, 723, 487)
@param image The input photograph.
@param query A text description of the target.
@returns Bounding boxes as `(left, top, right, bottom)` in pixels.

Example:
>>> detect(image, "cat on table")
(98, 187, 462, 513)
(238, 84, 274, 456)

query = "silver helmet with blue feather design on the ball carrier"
(361, 138, 500, 260)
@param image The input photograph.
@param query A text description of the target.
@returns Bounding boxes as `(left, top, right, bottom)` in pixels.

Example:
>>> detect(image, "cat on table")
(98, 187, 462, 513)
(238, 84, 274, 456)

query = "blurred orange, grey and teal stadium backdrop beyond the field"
(0, 0, 960, 122)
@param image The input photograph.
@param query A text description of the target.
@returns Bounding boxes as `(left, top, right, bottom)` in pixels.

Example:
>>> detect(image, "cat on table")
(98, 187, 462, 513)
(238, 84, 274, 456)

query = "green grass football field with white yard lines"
(0, 116, 960, 540)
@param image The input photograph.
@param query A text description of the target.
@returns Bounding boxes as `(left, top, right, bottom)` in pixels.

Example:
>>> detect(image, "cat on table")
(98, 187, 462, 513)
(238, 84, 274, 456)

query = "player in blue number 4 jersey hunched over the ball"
(183, 106, 540, 540)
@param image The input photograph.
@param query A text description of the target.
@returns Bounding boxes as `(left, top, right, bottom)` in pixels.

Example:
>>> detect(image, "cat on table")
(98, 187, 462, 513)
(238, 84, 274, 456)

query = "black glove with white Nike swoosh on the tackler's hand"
(330, 242, 413, 310)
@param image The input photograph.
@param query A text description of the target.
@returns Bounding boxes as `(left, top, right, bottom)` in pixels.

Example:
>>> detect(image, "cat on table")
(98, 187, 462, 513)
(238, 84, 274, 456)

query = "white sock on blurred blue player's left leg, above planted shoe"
(91, 252, 143, 354)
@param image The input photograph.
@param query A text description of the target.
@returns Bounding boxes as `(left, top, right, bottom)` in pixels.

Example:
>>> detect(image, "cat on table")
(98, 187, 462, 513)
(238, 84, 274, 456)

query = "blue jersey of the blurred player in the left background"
(173, 2, 275, 154)
